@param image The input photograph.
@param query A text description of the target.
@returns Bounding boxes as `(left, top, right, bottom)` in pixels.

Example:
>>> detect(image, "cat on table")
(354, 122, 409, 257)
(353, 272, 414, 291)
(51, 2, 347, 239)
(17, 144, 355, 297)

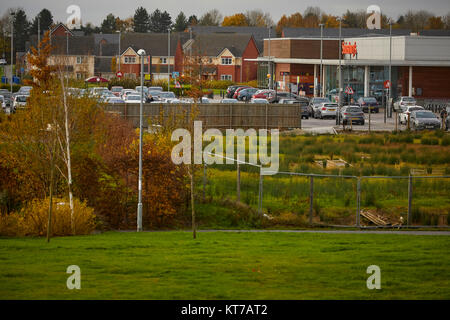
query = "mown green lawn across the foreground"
(0, 232, 450, 299)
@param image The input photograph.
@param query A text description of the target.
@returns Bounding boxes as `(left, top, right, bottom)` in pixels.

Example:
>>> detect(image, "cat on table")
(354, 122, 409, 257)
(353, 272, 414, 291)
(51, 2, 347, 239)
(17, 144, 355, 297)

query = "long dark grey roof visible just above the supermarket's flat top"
(283, 28, 411, 38)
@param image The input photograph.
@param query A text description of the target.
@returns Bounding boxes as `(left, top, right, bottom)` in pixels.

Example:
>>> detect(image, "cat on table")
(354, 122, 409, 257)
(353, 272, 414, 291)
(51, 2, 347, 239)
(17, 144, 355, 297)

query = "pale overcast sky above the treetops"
(0, 0, 450, 25)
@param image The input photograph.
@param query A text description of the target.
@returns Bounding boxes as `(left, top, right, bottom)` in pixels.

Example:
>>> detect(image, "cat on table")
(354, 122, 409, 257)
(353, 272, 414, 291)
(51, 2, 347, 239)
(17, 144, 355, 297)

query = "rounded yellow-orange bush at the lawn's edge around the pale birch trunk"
(0, 198, 95, 236)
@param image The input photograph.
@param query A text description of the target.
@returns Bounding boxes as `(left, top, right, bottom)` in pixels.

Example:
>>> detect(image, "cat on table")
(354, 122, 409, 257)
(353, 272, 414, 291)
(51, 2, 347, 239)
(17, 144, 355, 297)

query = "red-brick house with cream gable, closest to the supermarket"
(175, 34, 259, 82)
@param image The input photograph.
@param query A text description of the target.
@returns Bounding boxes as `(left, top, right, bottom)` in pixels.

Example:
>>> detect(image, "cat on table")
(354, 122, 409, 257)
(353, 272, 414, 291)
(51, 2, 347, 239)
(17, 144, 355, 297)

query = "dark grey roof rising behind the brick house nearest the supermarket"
(191, 26, 276, 52)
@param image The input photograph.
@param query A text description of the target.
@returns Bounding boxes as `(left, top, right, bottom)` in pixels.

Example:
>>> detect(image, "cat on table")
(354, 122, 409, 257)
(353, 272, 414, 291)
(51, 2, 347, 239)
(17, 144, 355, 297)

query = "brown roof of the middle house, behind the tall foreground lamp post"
(120, 32, 189, 56)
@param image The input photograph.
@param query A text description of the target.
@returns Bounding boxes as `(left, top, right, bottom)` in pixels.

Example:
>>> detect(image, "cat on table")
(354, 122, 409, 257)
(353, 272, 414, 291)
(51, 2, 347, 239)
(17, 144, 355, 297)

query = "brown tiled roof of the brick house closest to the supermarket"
(185, 33, 252, 57)
